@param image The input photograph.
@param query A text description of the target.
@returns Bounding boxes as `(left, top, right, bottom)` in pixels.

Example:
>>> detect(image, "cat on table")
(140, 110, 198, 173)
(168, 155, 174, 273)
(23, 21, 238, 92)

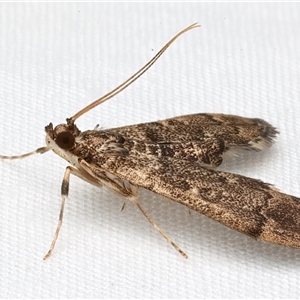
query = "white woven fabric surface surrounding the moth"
(0, 3, 300, 298)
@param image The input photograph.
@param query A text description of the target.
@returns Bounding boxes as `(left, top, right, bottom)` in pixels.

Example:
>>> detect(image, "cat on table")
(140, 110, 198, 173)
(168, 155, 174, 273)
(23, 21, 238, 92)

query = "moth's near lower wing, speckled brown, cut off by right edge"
(99, 156, 300, 248)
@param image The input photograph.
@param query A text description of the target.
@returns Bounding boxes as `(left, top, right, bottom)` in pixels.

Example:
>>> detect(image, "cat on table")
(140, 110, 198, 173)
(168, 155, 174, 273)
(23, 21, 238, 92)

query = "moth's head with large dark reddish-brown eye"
(45, 123, 80, 150)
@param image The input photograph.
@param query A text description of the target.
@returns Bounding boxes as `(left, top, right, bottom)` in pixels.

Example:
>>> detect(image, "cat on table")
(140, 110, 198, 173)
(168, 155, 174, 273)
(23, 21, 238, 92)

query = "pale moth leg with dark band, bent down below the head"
(44, 166, 87, 260)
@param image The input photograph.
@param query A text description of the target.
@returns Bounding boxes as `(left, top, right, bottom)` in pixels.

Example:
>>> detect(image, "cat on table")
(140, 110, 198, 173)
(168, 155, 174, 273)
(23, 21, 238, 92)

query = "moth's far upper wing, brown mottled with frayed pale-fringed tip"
(105, 114, 278, 151)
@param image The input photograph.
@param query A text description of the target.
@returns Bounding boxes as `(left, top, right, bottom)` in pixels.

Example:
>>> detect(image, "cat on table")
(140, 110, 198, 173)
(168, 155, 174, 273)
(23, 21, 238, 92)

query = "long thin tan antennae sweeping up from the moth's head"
(67, 23, 200, 124)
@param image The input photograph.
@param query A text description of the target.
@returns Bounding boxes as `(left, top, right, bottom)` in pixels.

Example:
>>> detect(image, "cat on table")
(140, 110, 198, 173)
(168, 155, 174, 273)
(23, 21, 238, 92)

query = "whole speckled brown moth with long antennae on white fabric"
(0, 23, 300, 259)
